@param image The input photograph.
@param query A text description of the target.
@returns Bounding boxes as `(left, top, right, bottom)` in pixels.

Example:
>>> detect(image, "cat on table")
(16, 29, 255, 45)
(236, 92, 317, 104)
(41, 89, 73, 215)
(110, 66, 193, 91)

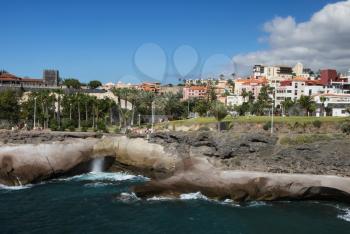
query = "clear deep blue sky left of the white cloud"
(0, 0, 336, 82)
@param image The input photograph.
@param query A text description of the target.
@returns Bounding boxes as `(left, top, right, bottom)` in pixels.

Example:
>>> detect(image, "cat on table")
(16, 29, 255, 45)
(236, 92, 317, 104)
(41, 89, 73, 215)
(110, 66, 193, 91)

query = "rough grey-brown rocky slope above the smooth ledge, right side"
(150, 131, 350, 177)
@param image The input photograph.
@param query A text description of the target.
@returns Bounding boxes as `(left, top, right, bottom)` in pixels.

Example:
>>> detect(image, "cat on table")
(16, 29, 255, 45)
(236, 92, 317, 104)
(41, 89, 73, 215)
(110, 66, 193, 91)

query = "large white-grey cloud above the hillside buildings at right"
(233, 0, 350, 74)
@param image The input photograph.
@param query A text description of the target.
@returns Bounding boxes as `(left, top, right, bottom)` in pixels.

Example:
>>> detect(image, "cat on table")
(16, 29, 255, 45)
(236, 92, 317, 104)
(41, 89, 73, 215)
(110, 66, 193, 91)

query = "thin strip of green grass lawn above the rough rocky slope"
(165, 116, 347, 125)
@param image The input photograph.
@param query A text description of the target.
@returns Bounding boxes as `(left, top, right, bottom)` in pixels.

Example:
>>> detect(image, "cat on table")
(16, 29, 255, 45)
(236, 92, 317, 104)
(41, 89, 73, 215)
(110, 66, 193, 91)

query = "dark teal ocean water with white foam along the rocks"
(0, 172, 350, 234)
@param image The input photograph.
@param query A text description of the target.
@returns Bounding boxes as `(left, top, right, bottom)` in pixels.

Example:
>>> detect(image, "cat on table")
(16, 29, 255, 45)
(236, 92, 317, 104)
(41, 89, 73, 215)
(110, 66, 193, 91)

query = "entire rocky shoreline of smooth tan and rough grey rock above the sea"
(0, 131, 350, 202)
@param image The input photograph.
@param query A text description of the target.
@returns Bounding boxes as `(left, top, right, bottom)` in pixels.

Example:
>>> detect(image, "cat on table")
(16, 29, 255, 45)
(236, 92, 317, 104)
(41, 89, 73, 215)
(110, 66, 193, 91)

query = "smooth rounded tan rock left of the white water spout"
(0, 139, 110, 185)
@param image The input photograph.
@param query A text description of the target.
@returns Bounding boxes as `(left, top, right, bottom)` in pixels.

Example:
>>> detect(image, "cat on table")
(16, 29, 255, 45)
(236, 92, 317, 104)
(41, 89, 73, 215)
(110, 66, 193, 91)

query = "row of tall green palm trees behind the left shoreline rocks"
(21, 90, 117, 128)
